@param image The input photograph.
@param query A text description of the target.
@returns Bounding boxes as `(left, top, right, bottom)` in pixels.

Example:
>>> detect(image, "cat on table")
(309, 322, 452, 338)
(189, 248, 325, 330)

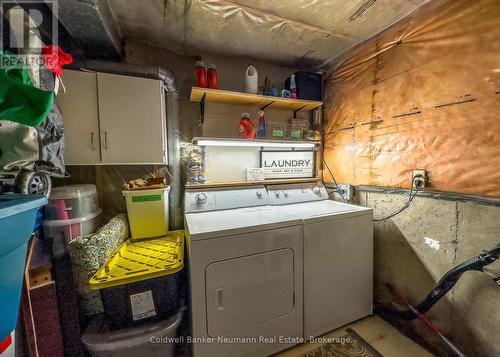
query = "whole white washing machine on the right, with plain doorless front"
(268, 182, 373, 338)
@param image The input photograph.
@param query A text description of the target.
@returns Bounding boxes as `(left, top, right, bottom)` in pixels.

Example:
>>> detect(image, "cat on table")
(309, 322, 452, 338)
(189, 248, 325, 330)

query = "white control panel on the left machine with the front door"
(184, 186, 269, 213)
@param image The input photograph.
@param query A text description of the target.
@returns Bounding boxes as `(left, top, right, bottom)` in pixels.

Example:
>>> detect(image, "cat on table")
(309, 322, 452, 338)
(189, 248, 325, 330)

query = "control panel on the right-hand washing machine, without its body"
(267, 182, 328, 206)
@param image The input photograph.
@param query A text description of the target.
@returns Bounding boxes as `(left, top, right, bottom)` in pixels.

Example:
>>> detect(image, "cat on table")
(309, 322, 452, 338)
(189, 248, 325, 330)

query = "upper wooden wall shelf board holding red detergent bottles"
(191, 87, 323, 111)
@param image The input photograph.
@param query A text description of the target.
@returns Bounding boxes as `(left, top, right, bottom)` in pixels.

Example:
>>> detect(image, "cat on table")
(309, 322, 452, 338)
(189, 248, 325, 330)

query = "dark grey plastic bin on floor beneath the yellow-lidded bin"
(82, 310, 183, 357)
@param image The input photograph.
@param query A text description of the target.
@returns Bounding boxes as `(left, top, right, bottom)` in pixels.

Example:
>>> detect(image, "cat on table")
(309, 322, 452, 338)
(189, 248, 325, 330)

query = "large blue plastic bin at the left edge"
(0, 194, 47, 341)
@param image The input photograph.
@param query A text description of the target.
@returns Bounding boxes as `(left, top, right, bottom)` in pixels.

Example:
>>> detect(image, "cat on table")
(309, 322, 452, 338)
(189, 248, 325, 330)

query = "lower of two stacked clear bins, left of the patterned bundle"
(42, 208, 102, 257)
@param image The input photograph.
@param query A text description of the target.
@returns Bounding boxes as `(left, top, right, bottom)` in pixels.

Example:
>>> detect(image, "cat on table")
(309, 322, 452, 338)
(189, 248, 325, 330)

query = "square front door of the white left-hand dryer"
(205, 249, 295, 337)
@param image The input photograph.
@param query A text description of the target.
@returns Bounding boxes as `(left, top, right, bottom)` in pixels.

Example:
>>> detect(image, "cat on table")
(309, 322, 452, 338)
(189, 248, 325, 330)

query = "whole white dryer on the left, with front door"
(185, 187, 303, 357)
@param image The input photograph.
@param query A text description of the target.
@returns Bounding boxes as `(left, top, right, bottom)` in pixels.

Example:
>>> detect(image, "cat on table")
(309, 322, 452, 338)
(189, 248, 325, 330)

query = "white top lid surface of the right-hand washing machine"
(282, 200, 372, 222)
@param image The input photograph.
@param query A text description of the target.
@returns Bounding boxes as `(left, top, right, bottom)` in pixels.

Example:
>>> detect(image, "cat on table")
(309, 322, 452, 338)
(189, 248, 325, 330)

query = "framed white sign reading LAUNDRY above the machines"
(261, 151, 314, 179)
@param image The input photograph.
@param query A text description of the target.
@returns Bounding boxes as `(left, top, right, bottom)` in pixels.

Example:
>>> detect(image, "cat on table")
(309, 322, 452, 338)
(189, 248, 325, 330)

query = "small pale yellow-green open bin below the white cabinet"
(123, 187, 170, 239)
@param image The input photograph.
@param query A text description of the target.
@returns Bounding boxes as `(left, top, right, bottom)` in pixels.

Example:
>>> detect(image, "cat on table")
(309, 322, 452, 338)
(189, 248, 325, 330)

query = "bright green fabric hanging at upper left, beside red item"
(0, 52, 54, 127)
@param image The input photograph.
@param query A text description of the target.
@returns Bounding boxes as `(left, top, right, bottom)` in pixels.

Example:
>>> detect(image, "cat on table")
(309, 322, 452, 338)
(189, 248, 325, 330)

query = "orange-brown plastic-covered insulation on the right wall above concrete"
(324, 0, 500, 197)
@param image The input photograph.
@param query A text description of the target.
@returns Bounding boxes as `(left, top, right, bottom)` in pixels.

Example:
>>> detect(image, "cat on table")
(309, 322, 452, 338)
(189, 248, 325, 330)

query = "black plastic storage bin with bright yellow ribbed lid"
(89, 231, 184, 329)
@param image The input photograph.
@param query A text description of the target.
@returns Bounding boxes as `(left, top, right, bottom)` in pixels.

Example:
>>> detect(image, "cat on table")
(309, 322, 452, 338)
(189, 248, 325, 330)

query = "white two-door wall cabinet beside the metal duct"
(59, 71, 167, 165)
